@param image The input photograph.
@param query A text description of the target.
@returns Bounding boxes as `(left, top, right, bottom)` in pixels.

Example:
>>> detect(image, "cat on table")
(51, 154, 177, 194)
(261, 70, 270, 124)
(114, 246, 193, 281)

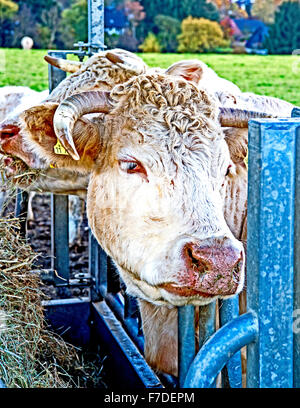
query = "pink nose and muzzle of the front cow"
(180, 238, 243, 296)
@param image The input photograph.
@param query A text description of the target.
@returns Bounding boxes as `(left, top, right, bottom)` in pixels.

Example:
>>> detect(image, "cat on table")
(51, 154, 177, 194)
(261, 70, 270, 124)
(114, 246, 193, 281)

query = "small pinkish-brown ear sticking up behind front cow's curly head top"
(166, 60, 207, 85)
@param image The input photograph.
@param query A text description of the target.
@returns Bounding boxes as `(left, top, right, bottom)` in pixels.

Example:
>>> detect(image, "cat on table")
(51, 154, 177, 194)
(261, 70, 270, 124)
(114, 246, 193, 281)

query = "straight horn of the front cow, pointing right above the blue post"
(219, 108, 277, 128)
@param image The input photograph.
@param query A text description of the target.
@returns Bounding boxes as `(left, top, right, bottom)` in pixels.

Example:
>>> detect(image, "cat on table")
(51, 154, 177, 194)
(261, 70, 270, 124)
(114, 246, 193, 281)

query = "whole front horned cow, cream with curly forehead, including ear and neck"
(0, 52, 296, 374)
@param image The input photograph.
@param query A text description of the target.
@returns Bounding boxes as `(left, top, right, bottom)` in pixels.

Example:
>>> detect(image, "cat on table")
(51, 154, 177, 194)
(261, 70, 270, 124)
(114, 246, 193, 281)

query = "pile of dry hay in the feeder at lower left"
(0, 218, 101, 388)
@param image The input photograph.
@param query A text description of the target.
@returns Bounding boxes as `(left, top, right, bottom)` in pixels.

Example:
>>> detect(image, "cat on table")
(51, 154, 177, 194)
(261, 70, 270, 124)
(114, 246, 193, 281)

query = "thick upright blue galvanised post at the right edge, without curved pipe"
(247, 119, 300, 388)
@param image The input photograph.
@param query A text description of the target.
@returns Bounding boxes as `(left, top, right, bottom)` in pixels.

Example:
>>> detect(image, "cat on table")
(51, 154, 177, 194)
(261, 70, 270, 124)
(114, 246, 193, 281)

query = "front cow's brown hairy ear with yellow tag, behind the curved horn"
(22, 103, 101, 172)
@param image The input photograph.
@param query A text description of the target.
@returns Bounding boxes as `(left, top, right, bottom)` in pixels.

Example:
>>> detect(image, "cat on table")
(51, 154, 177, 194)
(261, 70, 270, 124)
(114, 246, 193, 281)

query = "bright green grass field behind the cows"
(0, 49, 300, 105)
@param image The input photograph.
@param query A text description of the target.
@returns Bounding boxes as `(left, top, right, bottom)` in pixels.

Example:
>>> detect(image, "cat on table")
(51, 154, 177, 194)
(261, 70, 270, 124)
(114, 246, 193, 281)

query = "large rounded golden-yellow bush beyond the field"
(178, 17, 229, 52)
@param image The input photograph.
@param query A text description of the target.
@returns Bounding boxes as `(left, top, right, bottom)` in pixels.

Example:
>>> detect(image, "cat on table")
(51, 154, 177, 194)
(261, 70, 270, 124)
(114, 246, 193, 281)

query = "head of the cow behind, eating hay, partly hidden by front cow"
(0, 49, 147, 191)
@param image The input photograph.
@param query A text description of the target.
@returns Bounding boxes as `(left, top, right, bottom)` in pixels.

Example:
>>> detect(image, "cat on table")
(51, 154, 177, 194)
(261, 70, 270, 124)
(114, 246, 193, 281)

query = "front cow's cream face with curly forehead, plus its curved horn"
(17, 74, 244, 305)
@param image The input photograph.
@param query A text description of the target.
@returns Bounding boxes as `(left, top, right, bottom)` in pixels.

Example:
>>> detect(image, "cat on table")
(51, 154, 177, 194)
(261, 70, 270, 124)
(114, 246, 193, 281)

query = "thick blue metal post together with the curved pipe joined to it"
(183, 112, 300, 388)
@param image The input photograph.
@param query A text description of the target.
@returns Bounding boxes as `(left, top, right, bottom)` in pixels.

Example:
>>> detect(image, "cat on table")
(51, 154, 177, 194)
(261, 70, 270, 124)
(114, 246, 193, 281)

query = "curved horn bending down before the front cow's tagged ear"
(53, 91, 112, 160)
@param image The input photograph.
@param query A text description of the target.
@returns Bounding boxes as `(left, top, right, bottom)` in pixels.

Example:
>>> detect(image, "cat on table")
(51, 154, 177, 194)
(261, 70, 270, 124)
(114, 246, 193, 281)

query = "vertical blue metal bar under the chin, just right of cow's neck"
(178, 306, 195, 387)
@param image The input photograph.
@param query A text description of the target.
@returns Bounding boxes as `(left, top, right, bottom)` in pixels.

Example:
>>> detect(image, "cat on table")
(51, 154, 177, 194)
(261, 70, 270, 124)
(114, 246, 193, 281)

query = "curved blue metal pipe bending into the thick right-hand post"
(184, 313, 258, 388)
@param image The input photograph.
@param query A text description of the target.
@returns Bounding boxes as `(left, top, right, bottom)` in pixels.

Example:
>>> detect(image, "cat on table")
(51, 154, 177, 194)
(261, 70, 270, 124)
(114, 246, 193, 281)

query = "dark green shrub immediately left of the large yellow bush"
(154, 14, 180, 52)
